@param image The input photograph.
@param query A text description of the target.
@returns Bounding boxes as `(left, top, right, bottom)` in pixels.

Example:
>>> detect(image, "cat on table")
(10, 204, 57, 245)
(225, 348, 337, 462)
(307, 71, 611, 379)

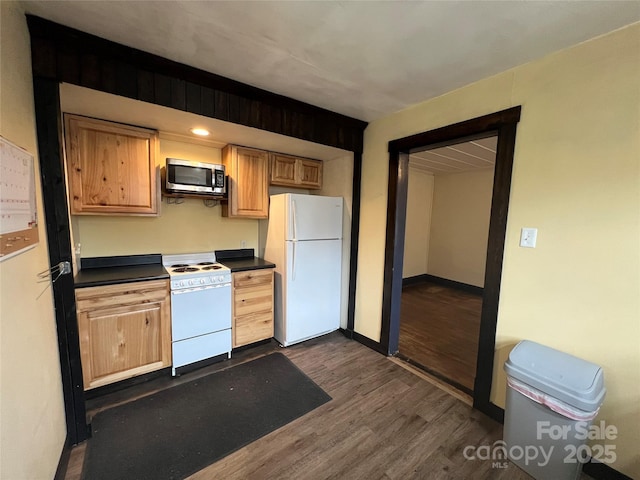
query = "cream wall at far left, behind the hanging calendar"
(0, 1, 66, 480)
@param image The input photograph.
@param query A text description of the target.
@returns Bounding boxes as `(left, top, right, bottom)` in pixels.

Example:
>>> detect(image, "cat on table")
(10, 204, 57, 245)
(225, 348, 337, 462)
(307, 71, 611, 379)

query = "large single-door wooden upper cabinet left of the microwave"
(64, 114, 159, 216)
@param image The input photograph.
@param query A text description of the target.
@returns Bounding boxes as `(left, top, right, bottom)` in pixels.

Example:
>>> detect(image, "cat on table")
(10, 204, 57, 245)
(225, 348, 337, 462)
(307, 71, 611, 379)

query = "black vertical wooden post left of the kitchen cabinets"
(33, 78, 89, 444)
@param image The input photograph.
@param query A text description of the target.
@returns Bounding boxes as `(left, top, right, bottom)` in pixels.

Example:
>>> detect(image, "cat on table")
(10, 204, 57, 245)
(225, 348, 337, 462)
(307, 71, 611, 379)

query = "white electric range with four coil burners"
(162, 252, 231, 376)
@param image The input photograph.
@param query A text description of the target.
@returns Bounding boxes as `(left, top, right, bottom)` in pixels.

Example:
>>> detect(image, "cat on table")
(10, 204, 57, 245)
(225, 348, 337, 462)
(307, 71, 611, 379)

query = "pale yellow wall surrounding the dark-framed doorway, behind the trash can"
(355, 24, 640, 477)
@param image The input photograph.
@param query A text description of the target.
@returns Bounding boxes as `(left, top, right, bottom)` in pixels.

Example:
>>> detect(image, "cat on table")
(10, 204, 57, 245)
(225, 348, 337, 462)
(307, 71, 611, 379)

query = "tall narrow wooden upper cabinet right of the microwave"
(222, 145, 269, 218)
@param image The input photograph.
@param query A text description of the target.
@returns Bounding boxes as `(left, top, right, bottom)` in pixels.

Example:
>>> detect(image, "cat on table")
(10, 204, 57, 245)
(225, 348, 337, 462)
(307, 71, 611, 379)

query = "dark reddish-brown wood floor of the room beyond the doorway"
(399, 282, 482, 393)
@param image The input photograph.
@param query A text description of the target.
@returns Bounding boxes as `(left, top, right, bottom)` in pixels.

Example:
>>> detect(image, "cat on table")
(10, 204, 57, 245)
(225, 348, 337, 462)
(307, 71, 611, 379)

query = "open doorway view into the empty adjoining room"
(398, 136, 497, 395)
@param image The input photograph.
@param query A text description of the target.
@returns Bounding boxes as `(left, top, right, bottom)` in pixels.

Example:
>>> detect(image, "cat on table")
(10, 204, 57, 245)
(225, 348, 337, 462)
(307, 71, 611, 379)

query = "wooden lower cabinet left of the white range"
(76, 280, 171, 390)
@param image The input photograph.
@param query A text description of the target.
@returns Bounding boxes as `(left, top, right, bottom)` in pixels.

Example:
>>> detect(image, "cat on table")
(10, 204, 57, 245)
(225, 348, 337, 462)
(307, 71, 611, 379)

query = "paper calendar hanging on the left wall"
(0, 136, 38, 261)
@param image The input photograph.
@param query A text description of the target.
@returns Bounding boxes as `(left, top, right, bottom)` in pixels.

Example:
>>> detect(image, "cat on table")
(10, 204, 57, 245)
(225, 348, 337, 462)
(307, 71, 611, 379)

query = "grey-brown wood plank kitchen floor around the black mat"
(66, 332, 560, 480)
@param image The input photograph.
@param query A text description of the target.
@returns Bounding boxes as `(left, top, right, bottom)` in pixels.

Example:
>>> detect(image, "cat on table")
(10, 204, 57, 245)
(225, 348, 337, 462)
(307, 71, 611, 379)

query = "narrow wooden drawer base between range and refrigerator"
(232, 268, 273, 348)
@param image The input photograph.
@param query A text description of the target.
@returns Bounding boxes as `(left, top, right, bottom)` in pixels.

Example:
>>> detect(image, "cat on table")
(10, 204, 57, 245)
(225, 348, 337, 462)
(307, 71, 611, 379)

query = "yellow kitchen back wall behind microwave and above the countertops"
(74, 139, 258, 258)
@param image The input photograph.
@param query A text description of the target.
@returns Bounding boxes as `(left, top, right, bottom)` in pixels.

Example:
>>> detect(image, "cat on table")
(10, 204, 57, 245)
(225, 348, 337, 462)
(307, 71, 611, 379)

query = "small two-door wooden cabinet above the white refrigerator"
(270, 153, 322, 190)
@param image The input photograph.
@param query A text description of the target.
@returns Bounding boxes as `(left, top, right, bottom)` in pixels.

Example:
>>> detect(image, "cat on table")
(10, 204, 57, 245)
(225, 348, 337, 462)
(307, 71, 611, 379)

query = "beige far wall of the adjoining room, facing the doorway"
(427, 169, 493, 287)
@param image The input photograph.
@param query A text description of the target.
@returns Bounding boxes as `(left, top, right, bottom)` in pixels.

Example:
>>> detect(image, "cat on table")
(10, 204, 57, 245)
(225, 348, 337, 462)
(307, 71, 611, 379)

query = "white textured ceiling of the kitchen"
(22, 0, 640, 121)
